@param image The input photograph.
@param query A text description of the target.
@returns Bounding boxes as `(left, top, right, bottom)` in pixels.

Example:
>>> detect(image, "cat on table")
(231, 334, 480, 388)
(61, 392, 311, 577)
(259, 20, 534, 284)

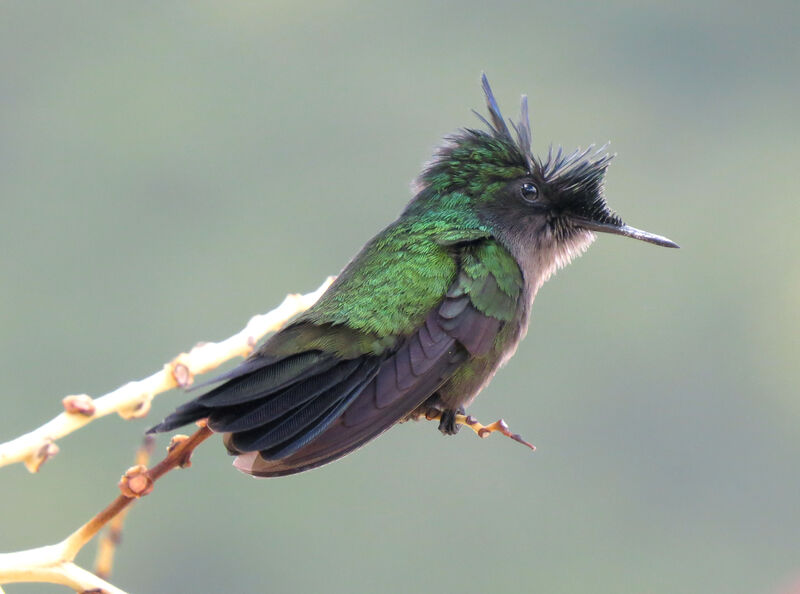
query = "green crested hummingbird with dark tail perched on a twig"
(149, 74, 678, 477)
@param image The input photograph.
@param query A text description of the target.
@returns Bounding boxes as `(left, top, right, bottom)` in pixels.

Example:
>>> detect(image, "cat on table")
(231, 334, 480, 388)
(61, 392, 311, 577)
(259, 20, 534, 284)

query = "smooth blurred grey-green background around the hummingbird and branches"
(0, 0, 800, 594)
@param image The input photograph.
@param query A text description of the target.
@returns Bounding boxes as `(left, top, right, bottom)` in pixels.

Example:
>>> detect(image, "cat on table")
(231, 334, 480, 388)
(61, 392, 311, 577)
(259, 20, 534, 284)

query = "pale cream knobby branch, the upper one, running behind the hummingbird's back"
(0, 277, 333, 472)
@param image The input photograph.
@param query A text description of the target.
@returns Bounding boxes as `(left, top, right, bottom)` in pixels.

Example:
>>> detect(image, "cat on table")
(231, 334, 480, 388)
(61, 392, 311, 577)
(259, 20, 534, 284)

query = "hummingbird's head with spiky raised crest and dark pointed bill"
(412, 75, 678, 276)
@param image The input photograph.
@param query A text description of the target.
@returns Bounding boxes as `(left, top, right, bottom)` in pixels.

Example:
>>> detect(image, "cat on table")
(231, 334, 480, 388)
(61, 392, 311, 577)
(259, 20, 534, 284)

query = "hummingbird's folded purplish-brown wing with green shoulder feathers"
(231, 242, 522, 477)
